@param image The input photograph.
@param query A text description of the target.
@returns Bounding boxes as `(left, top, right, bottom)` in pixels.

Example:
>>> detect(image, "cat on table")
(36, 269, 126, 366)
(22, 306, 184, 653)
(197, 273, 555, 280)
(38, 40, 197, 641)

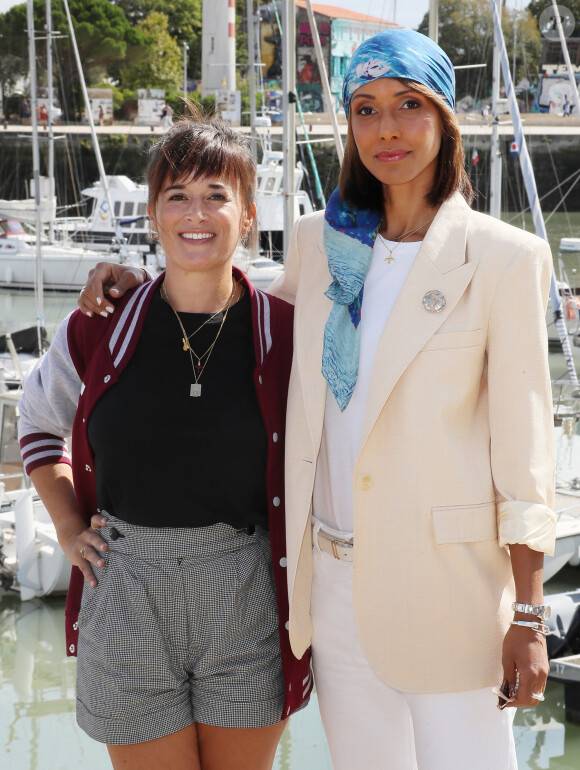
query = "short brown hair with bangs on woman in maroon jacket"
(145, 102, 257, 242)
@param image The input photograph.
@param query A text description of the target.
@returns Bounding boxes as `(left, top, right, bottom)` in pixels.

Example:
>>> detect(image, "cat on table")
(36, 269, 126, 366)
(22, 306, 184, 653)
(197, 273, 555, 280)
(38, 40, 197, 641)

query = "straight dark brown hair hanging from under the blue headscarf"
(338, 78, 473, 213)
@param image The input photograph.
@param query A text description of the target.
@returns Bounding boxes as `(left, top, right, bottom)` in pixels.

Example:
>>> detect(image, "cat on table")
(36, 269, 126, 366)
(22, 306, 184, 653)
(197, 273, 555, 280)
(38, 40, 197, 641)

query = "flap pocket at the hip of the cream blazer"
(431, 503, 497, 545)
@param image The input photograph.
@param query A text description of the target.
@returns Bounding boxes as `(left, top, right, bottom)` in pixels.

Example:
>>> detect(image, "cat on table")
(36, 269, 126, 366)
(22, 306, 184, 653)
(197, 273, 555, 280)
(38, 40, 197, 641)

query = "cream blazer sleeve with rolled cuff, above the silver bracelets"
(487, 237, 556, 555)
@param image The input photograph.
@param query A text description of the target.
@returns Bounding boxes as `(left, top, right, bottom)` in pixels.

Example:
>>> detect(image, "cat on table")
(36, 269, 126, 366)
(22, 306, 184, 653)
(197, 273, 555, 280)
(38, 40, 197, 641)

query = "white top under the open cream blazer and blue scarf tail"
(313, 235, 422, 537)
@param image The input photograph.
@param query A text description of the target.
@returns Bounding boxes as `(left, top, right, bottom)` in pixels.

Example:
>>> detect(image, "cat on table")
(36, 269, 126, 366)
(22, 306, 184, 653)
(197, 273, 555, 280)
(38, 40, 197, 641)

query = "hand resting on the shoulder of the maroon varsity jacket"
(78, 262, 146, 318)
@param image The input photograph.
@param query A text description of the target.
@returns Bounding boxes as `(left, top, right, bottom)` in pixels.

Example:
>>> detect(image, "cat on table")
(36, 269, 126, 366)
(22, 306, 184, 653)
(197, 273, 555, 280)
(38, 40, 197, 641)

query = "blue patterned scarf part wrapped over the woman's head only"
(342, 29, 455, 117)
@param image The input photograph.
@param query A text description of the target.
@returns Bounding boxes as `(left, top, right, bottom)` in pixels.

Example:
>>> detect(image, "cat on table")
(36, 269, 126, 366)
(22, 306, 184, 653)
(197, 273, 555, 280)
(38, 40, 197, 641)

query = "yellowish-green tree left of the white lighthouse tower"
(120, 11, 183, 91)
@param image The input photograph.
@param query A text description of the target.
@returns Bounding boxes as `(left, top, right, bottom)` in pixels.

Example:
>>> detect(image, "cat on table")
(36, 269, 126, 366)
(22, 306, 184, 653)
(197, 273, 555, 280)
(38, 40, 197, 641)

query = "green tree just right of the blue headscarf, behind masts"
(418, 0, 544, 100)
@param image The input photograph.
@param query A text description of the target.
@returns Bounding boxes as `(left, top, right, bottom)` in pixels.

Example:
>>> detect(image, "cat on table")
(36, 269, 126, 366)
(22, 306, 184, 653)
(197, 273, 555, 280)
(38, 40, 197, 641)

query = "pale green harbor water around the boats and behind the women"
(0, 214, 580, 770)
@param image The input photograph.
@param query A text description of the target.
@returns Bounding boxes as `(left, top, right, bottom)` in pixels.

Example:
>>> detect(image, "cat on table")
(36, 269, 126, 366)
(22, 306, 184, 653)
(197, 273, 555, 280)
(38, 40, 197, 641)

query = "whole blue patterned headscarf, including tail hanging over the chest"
(322, 29, 455, 411)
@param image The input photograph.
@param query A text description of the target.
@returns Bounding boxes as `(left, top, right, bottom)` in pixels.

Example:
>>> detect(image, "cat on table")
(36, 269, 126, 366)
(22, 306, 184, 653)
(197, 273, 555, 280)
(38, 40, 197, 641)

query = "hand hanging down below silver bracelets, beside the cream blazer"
(502, 626, 550, 707)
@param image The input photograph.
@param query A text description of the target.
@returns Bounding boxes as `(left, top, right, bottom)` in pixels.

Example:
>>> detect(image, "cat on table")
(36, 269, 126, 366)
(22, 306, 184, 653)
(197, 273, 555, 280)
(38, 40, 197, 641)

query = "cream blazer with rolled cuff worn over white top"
(272, 193, 555, 693)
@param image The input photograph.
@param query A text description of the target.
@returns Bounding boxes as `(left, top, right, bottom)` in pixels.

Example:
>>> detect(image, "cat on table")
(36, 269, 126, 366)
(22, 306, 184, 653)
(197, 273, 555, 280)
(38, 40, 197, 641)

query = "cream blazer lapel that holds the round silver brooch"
(360, 193, 477, 448)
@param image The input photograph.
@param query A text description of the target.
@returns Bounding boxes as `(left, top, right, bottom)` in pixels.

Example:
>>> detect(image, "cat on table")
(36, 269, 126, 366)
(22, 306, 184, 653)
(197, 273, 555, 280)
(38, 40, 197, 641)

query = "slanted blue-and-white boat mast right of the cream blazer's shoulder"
(490, 0, 578, 387)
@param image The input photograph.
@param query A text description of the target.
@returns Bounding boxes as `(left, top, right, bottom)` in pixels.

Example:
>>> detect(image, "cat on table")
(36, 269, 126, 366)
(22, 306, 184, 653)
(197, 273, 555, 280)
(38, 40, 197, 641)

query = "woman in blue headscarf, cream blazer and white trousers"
(82, 30, 555, 770)
